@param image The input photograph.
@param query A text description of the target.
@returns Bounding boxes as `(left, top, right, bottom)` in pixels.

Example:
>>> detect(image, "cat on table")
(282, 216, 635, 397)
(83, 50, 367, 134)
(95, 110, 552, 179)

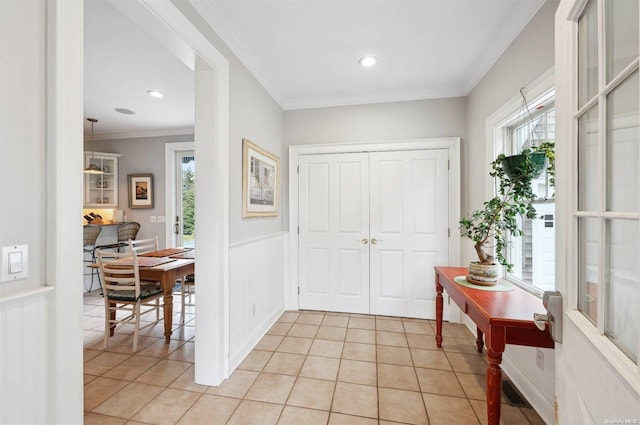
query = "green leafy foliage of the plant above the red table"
(459, 152, 544, 271)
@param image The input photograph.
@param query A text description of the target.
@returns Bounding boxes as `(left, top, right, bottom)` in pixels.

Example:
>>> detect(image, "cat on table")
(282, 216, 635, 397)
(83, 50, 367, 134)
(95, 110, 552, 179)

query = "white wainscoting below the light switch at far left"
(0, 287, 53, 424)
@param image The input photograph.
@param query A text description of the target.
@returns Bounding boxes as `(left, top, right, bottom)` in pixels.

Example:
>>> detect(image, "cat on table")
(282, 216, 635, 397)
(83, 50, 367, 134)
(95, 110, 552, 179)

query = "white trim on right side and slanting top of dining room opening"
(92, 0, 229, 385)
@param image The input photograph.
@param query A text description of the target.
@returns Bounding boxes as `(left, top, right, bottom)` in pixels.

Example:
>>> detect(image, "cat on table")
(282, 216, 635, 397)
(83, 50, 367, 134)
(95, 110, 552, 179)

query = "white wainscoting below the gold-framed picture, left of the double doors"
(229, 232, 289, 372)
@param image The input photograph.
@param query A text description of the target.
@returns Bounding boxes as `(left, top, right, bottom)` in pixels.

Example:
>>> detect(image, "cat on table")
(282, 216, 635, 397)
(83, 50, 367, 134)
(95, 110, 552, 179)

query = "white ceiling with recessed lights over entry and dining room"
(85, 0, 544, 138)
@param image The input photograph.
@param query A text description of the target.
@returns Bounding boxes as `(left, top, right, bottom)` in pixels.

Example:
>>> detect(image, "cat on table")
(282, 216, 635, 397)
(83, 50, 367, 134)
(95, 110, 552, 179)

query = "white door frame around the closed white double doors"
(285, 137, 460, 312)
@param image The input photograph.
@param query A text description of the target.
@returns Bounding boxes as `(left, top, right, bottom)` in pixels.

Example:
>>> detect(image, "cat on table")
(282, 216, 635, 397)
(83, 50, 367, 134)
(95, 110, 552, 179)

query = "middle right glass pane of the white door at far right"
(607, 71, 640, 212)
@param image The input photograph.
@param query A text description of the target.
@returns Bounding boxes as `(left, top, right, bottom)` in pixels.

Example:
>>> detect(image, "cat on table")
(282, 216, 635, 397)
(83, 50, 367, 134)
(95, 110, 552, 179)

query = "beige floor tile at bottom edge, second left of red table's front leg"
(378, 388, 428, 425)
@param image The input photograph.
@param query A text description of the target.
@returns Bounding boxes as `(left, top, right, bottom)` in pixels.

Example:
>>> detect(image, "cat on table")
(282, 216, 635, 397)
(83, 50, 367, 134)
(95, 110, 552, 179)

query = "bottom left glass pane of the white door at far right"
(578, 218, 600, 325)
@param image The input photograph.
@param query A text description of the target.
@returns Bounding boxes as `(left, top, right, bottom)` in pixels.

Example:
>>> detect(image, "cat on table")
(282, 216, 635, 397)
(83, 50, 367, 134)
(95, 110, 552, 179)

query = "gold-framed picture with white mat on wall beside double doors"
(242, 139, 280, 218)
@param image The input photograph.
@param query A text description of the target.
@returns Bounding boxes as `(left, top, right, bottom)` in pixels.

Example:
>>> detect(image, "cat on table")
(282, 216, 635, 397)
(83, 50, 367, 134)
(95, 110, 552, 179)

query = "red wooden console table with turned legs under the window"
(435, 266, 554, 425)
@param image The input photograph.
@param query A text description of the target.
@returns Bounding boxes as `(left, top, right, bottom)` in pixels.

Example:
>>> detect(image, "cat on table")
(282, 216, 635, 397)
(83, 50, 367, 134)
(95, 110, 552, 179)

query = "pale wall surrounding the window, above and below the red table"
(462, 0, 559, 423)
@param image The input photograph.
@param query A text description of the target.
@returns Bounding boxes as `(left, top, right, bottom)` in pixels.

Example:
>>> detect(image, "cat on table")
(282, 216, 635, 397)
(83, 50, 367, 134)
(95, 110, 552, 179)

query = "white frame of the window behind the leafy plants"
(485, 68, 555, 297)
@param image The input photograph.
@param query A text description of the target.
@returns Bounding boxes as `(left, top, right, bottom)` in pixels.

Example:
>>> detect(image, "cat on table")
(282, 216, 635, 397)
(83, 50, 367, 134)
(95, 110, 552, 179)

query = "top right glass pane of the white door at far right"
(605, 0, 638, 82)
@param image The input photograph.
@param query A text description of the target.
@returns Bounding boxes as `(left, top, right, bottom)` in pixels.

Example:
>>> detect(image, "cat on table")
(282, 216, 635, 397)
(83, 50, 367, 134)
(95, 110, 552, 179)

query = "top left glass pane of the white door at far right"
(578, 0, 598, 107)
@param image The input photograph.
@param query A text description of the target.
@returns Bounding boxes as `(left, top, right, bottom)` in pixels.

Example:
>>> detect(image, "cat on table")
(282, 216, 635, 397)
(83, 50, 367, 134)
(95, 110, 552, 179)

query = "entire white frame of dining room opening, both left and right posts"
(50, 0, 229, 404)
